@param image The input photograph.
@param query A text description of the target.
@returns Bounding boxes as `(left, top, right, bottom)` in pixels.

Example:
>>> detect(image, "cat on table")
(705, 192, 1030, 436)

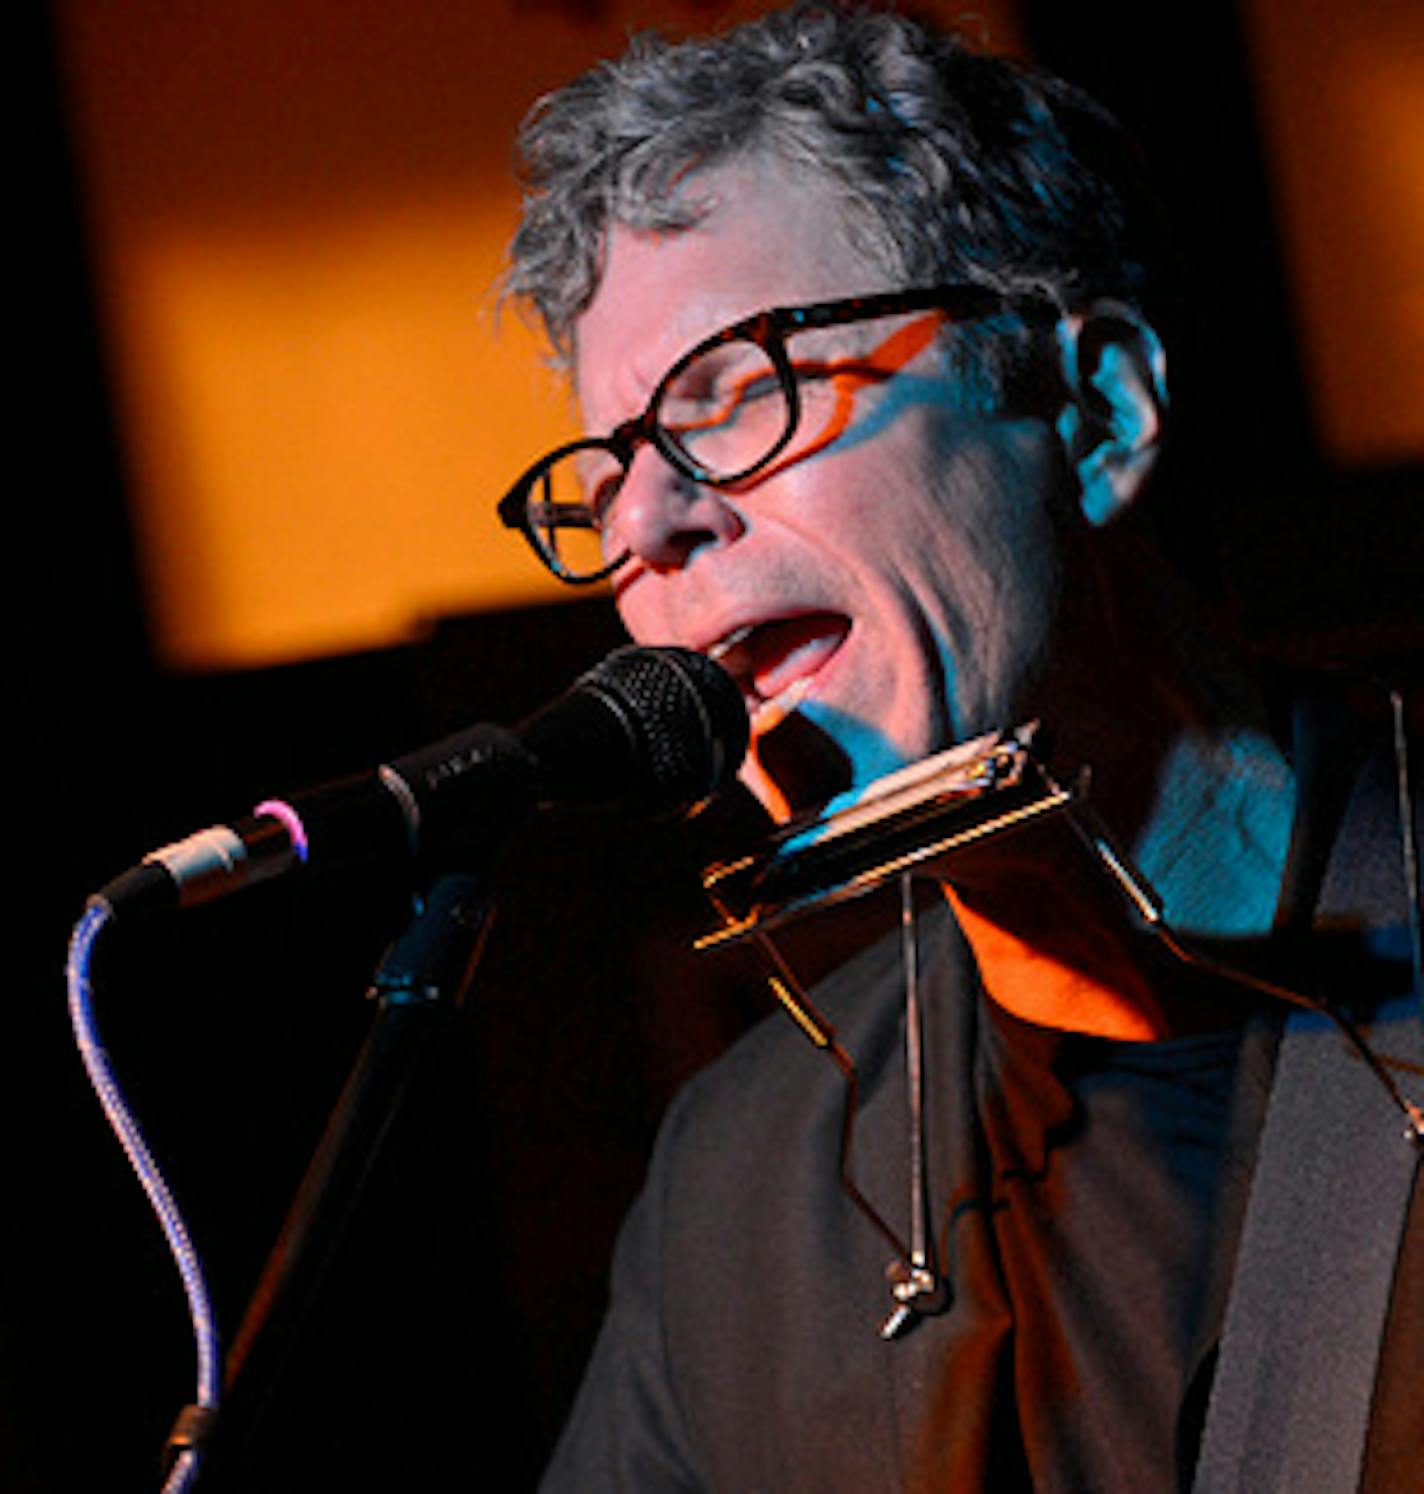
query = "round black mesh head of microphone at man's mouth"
(580, 647, 750, 814)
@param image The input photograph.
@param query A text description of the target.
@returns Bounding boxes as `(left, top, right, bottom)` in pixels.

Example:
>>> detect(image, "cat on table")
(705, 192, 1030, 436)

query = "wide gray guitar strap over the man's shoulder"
(1192, 693, 1424, 1494)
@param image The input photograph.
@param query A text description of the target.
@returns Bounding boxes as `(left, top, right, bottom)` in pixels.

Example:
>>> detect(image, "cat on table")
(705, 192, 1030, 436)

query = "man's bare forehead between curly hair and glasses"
(574, 160, 885, 427)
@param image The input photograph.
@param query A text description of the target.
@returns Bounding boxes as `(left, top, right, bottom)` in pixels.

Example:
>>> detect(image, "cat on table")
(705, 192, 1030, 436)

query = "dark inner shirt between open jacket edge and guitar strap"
(925, 1002, 1270, 1491)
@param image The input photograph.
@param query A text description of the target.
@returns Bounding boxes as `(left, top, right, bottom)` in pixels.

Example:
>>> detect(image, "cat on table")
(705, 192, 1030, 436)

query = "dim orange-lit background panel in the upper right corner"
(1242, 0, 1424, 465)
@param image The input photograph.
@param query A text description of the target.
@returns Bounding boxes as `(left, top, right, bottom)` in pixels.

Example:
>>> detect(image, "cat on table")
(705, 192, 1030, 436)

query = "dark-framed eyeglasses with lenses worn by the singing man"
(499, 284, 1009, 586)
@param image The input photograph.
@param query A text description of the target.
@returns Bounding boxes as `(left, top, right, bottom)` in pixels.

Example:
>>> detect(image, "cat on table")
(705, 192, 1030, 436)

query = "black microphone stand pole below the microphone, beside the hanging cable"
(180, 872, 493, 1491)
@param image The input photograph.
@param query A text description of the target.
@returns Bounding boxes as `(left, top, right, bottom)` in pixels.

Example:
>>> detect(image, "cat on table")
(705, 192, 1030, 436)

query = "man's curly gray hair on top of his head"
(504, 3, 1157, 362)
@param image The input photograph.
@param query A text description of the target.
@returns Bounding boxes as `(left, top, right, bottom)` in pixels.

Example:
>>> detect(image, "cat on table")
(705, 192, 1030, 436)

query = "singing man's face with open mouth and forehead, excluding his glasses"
(575, 163, 1064, 814)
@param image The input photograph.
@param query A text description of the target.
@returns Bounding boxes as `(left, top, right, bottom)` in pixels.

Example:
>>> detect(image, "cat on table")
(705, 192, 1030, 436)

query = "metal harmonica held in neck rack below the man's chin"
(695, 723, 1085, 949)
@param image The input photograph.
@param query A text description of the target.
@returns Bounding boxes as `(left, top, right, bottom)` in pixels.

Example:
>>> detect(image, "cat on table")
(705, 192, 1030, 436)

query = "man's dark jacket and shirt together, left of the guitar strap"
(547, 911, 1275, 1494)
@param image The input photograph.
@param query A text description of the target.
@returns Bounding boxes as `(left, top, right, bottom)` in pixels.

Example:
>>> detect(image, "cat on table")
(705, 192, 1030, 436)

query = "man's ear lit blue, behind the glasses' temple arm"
(1058, 300, 1167, 526)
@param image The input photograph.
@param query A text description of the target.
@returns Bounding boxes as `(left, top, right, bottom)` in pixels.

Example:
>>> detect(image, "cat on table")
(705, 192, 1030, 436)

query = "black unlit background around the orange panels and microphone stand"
(13, 0, 1424, 1490)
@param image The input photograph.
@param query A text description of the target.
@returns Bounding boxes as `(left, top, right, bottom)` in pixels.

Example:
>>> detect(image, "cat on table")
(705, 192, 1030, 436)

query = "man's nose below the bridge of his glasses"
(607, 447, 747, 571)
